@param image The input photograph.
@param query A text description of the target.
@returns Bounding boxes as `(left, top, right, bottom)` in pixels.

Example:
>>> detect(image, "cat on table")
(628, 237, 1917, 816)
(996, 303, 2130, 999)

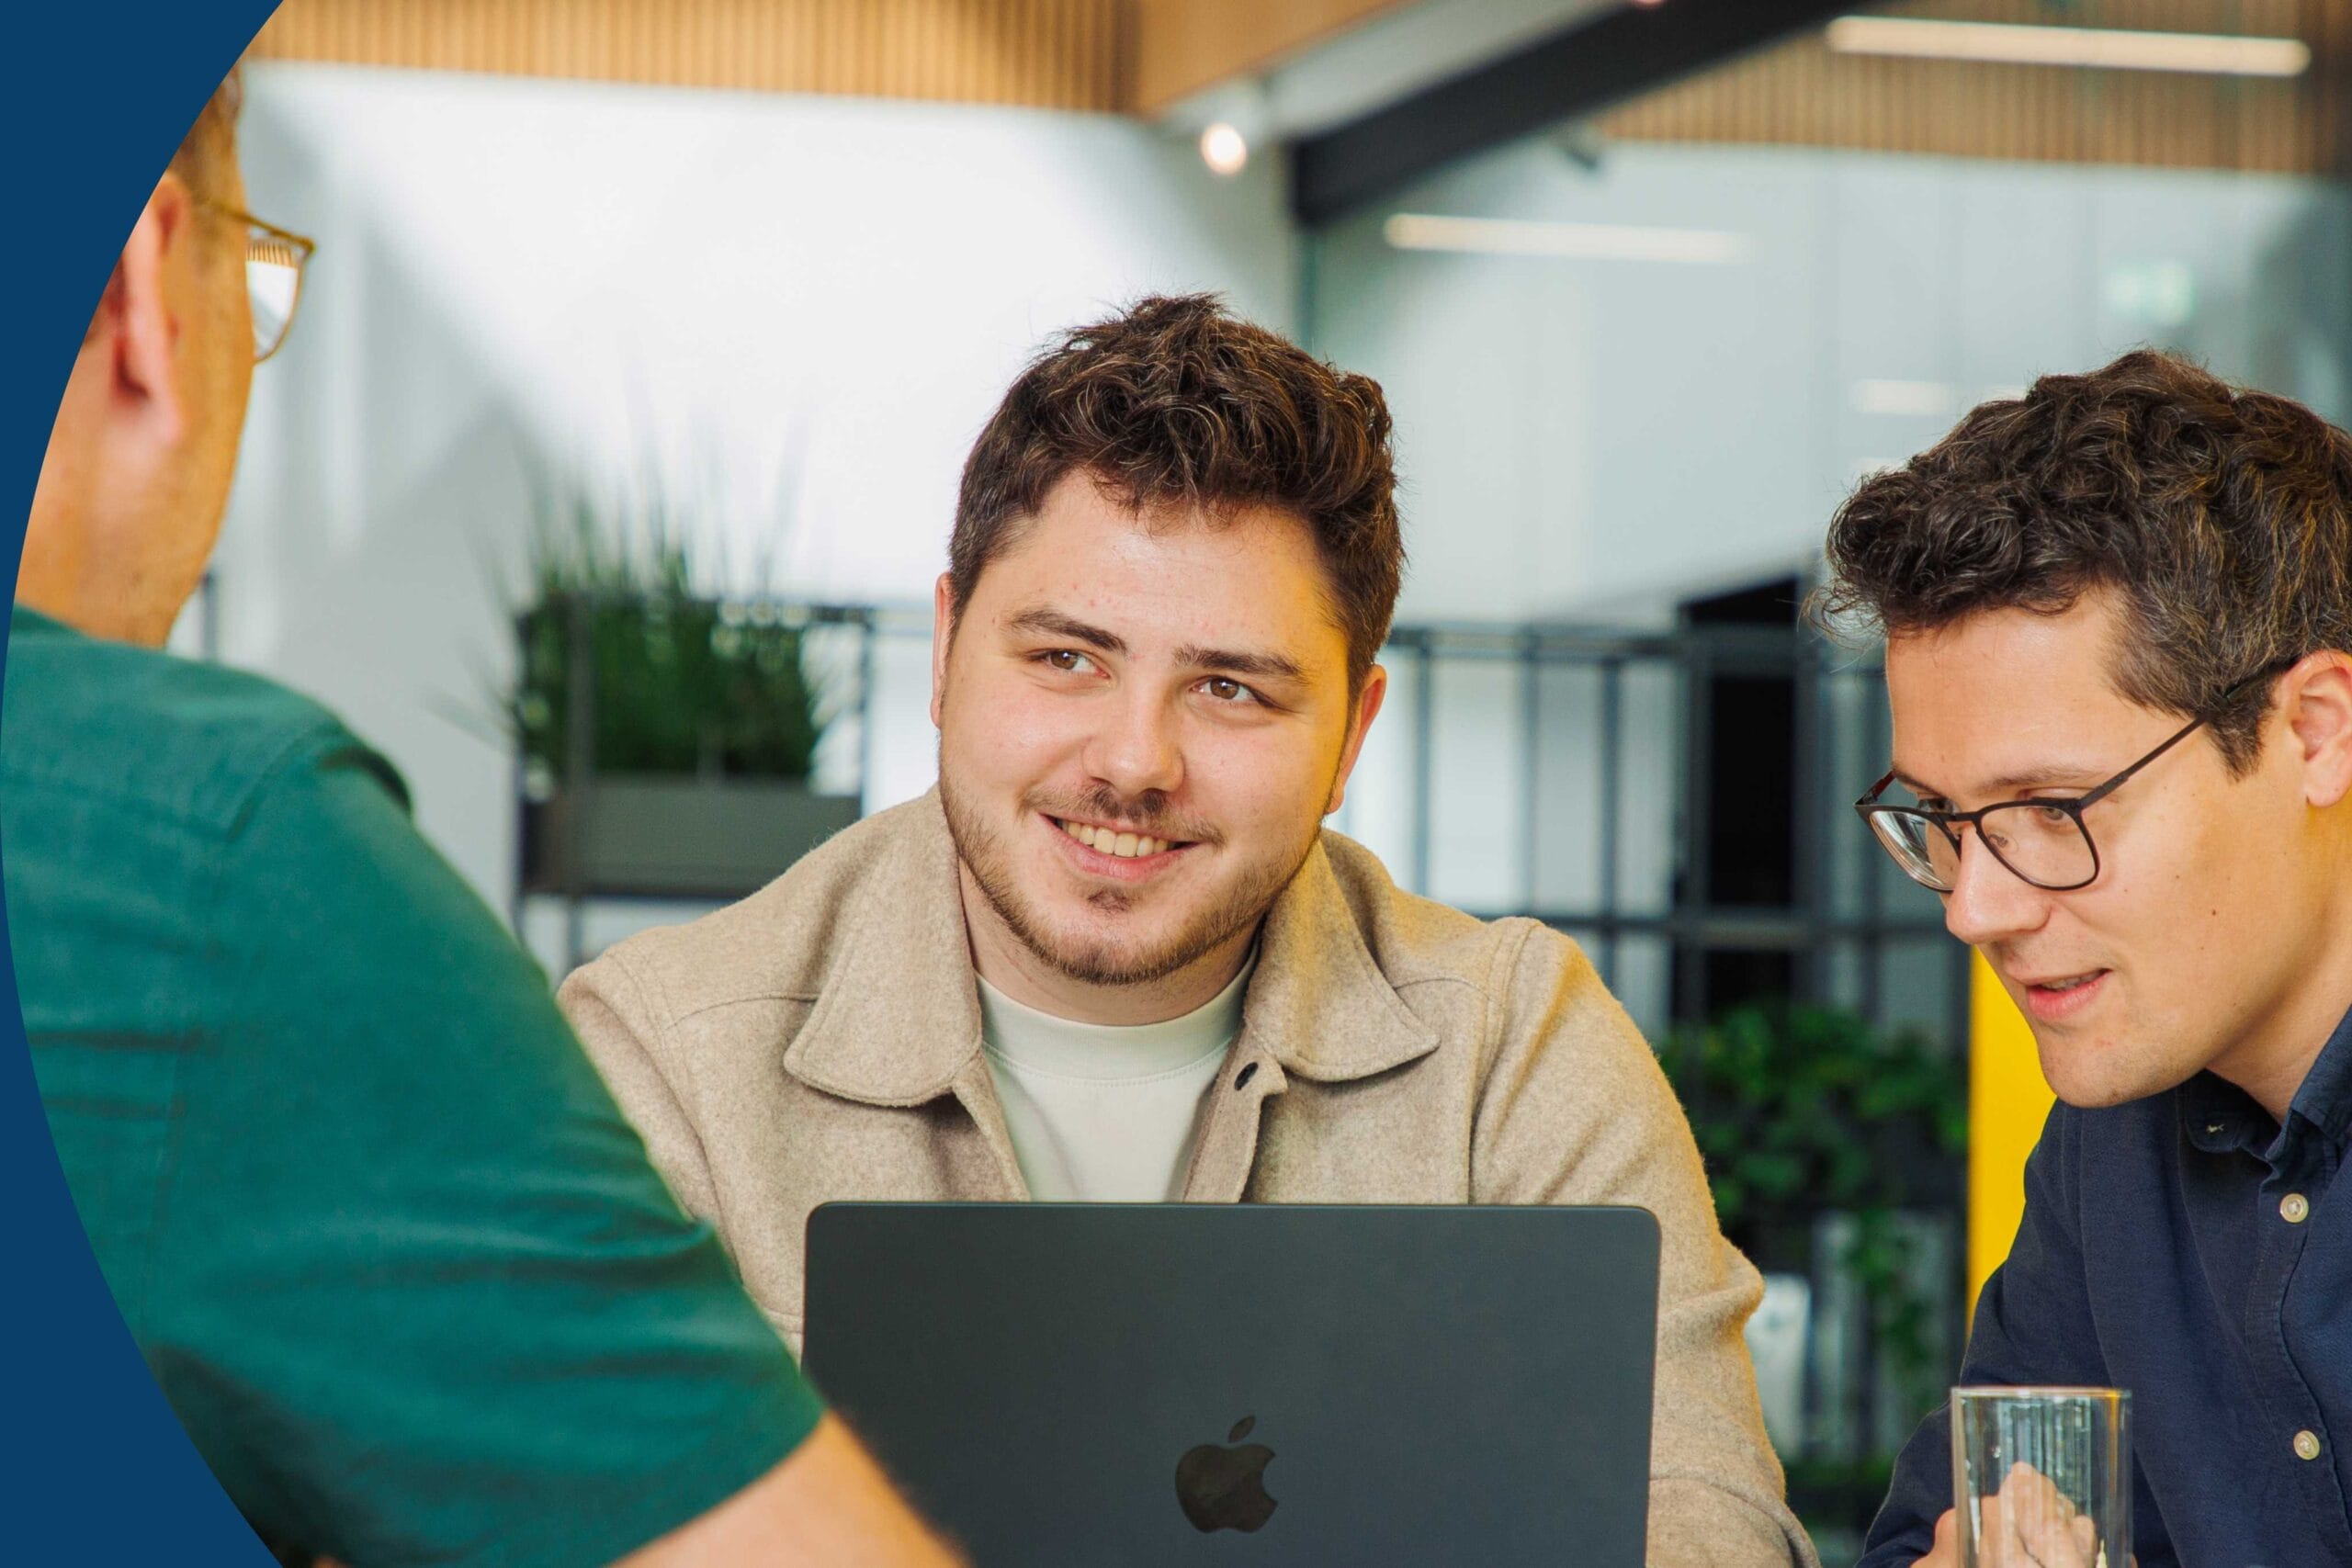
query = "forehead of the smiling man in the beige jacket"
(971, 475, 1345, 663)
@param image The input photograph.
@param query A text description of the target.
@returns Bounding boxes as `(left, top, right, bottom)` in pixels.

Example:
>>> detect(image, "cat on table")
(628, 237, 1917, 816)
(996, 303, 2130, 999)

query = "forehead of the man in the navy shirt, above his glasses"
(1886, 594, 2154, 795)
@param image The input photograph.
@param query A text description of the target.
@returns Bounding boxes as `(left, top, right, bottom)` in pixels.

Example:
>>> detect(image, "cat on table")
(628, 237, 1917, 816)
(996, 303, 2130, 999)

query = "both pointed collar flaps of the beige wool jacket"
(783, 790, 1437, 1105)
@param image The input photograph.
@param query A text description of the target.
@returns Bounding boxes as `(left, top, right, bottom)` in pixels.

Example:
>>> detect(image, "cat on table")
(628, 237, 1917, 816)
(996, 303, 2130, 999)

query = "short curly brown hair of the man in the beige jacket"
(948, 294, 1404, 691)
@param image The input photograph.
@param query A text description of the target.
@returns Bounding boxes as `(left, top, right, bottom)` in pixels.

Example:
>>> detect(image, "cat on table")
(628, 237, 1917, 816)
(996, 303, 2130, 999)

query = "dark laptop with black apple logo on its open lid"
(805, 1203, 1658, 1568)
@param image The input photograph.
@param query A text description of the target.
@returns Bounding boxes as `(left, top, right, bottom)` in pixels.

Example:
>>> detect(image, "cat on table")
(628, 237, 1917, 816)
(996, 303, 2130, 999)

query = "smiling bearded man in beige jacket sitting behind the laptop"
(562, 299, 1814, 1568)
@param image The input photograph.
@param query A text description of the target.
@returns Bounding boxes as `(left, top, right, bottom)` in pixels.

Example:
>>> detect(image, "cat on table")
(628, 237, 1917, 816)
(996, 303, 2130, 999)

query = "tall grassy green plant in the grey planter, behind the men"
(505, 465, 831, 795)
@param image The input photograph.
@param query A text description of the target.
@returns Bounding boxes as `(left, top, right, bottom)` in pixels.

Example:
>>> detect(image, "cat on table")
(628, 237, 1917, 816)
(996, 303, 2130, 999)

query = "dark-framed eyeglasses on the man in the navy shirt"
(1853, 665, 2286, 894)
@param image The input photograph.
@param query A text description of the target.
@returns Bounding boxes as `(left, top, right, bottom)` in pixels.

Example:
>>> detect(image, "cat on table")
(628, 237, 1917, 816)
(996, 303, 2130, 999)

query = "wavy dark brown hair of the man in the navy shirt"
(1811, 350, 2352, 773)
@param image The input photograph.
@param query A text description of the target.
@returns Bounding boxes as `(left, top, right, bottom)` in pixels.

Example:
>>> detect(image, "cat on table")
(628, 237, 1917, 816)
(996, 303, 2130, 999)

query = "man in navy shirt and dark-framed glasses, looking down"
(1820, 353, 2352, 1568)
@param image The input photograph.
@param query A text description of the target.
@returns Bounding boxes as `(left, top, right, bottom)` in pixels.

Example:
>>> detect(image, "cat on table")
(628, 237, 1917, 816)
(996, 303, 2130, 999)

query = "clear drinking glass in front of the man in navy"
(1952, 1389, 2131, 1568)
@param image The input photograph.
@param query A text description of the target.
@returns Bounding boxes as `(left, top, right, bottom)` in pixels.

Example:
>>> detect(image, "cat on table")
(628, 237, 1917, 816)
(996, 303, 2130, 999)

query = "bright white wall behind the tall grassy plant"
(217, 63, 1296, 921)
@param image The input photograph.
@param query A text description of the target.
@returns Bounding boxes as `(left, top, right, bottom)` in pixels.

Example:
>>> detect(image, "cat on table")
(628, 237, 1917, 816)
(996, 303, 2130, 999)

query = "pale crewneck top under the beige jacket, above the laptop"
(981, 954, 1256, 1203)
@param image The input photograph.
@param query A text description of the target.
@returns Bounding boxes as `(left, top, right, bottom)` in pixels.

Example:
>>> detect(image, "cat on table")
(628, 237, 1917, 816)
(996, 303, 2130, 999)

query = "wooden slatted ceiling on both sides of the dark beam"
(254, 0, 2352, 174)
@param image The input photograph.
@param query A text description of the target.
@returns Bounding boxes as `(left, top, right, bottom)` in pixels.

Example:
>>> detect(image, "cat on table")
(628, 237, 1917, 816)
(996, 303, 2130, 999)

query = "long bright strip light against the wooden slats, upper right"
(1830, 17, 2312, 75)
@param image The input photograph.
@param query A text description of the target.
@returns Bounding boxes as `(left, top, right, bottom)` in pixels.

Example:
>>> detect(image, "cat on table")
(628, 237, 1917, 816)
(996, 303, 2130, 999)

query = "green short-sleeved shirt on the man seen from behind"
(0, 609, 819, 1568)
